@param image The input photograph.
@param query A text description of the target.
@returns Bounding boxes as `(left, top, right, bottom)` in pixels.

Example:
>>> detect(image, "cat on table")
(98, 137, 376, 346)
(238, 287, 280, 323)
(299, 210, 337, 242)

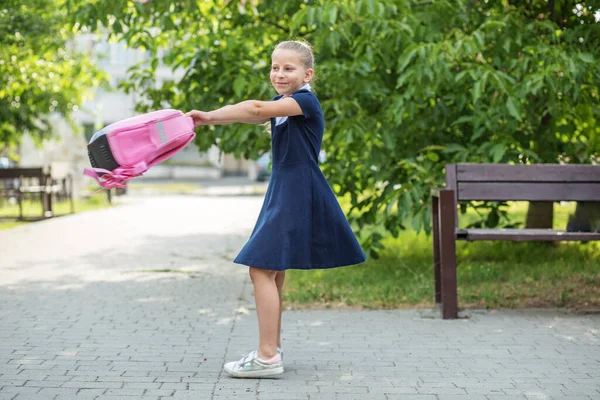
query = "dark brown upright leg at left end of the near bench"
(438, 190, 458, 319)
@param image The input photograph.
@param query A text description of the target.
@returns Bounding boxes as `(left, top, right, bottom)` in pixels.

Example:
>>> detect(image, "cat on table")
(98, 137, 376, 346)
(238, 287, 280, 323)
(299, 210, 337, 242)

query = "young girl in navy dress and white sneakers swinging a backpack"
(186, 41, 365, 378)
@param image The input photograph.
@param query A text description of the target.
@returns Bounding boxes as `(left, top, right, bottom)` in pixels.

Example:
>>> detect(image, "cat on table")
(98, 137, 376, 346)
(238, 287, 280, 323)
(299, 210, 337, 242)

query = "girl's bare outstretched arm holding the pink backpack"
(185, 97, 302, 126)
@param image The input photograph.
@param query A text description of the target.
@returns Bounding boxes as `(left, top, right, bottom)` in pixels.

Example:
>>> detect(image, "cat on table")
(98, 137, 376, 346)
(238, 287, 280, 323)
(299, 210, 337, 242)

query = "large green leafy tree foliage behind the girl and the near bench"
(67, 0, 600, 254)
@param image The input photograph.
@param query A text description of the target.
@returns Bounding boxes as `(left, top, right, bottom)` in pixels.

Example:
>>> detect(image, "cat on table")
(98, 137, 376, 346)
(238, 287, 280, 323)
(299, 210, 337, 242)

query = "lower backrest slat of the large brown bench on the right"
(458, 182, 600, 201)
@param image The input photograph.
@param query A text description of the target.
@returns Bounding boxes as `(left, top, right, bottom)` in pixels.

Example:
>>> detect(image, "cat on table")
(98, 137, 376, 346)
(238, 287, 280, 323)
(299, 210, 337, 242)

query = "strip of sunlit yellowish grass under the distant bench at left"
(0, 193, 110, 229)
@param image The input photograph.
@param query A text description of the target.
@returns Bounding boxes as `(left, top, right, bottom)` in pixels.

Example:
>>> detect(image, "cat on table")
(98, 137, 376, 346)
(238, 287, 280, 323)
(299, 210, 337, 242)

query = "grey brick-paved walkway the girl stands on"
(0, 196, 600, 400)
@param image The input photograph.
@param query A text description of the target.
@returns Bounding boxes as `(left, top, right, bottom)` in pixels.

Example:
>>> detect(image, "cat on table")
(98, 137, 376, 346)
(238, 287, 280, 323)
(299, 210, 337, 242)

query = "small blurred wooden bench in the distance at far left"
(0, 167, 74, 219)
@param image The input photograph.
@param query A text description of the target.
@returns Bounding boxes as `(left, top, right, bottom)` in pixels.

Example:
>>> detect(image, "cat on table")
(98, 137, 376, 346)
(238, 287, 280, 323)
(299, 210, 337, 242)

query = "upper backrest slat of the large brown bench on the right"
(456, 164, 600, 182)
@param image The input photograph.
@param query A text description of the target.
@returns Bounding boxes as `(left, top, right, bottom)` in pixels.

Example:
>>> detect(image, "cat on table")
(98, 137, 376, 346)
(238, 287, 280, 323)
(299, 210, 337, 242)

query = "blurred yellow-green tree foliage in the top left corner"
(0, 0, 103, 149)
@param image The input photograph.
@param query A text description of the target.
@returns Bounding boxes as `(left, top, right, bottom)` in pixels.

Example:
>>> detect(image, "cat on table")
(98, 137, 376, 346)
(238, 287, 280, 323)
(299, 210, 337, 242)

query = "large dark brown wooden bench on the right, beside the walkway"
(432, 164, 600, 319)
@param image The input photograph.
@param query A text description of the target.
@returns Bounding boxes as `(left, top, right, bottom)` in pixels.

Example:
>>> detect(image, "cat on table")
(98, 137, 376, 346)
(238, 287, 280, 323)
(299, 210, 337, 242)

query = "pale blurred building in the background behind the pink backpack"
(19, 34, 254, 193)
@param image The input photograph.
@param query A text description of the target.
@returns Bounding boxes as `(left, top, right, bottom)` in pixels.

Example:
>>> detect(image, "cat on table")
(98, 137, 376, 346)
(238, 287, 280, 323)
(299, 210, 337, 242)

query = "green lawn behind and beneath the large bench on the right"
(284, 202, 600, 309)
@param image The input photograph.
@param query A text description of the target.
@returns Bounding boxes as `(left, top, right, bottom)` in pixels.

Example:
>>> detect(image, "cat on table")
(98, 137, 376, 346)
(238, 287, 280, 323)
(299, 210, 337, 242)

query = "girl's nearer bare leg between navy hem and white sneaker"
(250, 267, 281, 360)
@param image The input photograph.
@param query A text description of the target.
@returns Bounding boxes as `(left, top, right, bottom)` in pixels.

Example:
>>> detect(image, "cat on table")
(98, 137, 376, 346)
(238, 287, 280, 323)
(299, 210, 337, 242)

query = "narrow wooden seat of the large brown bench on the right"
(455, 229, 600, 242)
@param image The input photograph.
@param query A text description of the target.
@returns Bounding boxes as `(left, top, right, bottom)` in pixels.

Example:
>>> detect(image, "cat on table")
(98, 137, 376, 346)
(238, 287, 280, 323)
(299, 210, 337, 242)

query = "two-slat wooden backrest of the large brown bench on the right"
(446, 164, 600, 202)
